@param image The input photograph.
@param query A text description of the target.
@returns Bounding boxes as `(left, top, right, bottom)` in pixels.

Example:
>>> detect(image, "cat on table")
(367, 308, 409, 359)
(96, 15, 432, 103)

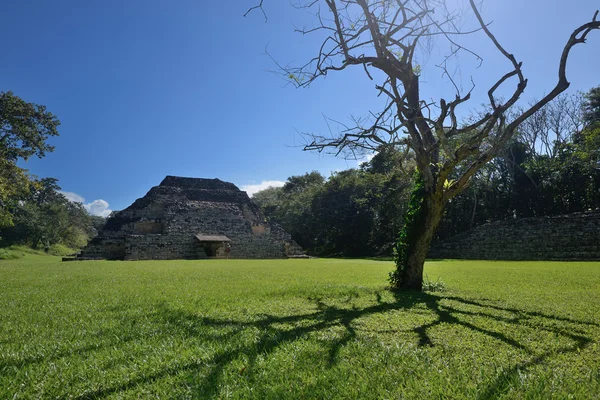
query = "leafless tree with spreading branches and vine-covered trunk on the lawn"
(247, 0, 600, 290)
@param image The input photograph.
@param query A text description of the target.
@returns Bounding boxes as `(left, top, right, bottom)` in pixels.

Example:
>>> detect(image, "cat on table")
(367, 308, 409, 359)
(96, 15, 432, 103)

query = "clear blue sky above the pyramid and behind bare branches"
(0, 0, 600, 214)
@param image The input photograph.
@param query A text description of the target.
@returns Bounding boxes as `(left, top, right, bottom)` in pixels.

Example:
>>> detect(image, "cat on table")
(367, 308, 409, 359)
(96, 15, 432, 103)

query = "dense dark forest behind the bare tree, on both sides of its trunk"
(253, 87, 600, 257)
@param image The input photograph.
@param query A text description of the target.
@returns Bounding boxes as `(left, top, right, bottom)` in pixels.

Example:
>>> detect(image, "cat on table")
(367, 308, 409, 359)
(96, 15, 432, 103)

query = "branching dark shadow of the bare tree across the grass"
(70, 293, 599, 399)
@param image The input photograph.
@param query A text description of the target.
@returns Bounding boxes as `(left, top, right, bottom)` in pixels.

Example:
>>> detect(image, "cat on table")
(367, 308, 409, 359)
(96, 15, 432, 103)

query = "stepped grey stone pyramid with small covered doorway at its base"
(77, 176, 304, 260)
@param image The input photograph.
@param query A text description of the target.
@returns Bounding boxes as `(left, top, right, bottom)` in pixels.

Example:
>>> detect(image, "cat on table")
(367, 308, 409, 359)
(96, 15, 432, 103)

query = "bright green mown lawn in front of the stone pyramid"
(0, 254, 600, 399)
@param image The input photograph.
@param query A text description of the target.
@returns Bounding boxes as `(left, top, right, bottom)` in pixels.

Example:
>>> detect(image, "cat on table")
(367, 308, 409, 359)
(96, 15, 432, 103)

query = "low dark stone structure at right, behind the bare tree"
(427, 211, 600, 260)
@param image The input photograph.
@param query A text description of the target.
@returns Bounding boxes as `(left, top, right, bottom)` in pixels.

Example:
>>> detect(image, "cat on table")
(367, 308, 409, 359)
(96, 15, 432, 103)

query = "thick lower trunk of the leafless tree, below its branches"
(394, 188, 444, 291)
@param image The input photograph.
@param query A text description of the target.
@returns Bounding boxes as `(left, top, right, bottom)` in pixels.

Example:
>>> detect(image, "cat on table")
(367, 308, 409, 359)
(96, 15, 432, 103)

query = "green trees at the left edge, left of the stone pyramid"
(0, 92, 104, 250)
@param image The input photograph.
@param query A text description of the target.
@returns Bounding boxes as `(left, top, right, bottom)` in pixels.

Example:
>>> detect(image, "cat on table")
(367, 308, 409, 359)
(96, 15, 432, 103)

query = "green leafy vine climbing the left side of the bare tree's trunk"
(389, 170, 425, 289)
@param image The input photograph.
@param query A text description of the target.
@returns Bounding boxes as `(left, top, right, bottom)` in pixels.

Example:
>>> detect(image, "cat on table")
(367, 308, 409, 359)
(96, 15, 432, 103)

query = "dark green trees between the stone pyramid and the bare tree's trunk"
(253, 157, 411, 257)
